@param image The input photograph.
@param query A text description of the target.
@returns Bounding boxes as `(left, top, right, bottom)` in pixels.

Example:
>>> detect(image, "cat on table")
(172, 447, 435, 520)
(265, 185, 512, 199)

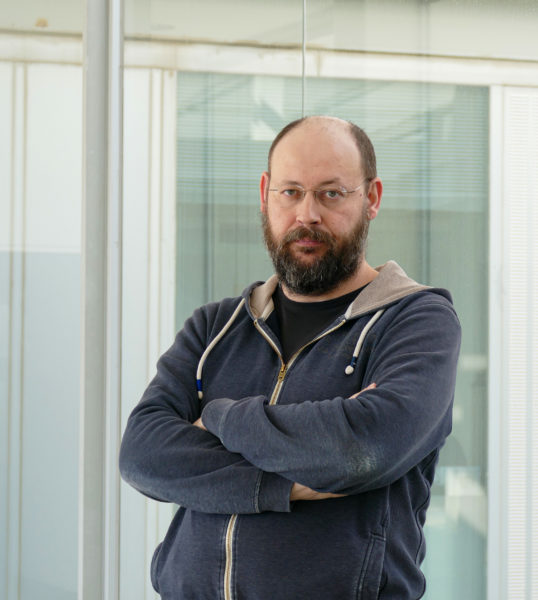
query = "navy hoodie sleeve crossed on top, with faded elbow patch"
(202, 294, 460, 494)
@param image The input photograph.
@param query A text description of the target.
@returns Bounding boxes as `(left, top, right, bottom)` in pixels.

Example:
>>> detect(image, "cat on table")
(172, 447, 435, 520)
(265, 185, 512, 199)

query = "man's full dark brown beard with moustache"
(262, 205, 370, 296)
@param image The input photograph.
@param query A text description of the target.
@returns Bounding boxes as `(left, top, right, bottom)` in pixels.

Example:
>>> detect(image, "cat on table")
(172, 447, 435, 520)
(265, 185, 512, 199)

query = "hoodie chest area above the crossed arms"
(197, 319, 376, 405)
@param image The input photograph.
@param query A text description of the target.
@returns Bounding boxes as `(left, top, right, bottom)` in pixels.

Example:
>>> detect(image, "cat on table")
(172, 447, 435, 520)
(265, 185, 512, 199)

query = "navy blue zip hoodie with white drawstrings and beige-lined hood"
(120, 262, 460, 600)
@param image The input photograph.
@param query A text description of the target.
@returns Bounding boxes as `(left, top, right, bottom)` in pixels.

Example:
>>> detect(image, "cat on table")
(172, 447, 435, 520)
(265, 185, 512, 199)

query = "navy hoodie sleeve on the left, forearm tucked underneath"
(119, 309, 292, 514)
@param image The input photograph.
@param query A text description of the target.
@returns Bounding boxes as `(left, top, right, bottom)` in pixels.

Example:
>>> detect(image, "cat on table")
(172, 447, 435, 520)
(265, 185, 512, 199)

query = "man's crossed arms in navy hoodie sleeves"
(120, 304, 459, 514)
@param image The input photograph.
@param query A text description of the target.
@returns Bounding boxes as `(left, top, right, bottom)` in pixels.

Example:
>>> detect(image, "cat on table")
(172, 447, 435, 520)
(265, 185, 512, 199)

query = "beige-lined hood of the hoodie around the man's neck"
(243, 260, 434, 320)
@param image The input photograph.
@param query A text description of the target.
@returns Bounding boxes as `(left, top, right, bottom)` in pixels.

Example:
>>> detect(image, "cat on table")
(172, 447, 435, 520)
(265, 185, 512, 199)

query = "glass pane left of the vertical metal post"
(0, 9, 83, 600)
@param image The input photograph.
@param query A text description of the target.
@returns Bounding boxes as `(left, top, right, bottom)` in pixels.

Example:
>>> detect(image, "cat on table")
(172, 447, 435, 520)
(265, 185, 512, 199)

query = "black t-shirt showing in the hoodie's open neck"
(273, 284, 368, 362)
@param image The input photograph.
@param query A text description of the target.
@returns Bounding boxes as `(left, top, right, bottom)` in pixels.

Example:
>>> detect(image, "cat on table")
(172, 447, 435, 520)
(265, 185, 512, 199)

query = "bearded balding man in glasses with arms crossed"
(120, 117, 460, 600)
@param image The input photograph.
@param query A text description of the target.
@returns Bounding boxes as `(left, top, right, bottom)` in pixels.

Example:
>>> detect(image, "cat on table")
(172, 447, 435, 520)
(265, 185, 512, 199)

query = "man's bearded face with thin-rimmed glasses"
(262, 121, 369, 295)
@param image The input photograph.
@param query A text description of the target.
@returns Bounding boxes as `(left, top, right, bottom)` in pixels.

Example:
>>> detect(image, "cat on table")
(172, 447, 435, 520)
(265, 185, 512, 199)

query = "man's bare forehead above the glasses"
(271, 119, 361, 182)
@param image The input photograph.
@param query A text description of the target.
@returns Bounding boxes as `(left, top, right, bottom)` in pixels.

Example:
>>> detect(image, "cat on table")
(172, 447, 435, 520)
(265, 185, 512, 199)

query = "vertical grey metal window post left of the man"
(78, 0, 123, 600)
